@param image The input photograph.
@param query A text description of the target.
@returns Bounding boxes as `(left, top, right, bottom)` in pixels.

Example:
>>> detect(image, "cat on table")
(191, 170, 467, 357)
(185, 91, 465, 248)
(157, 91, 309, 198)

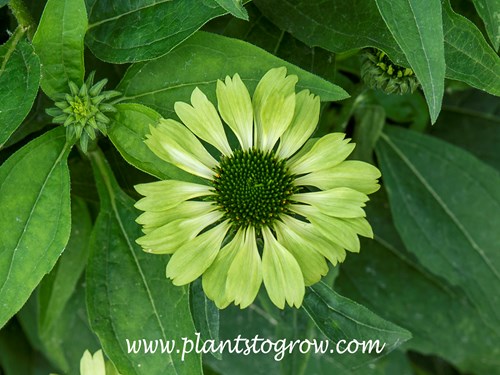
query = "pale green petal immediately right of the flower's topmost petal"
(278, 90, 320, 159)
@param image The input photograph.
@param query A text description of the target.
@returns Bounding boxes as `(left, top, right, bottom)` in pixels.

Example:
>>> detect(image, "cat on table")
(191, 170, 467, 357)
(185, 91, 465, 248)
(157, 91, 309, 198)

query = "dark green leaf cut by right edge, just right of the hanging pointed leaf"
(443, 1, 500, 96)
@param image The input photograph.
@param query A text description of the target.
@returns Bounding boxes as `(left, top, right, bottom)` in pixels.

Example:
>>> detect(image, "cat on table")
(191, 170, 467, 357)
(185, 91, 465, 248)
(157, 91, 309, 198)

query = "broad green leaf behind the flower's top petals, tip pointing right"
(117, 32, 348, 117)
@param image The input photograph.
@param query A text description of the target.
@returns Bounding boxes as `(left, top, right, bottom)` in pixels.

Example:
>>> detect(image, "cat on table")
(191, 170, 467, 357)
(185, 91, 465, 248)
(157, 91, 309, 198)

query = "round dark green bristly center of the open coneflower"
(212, 149, 295, 228)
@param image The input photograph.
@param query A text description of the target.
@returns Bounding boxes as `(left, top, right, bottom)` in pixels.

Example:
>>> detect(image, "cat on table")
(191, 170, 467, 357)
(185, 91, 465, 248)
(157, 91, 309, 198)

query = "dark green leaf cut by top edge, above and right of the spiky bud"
(86, 0, 226, 64)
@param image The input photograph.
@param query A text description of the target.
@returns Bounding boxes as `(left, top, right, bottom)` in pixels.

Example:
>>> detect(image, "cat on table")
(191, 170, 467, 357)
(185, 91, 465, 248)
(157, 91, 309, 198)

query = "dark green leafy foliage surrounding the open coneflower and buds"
(0, 0, 500, 375)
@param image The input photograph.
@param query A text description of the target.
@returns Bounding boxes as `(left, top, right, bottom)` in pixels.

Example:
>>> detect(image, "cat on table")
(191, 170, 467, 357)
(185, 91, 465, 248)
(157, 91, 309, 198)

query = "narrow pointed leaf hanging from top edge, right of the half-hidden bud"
(376, 0, 446, 123)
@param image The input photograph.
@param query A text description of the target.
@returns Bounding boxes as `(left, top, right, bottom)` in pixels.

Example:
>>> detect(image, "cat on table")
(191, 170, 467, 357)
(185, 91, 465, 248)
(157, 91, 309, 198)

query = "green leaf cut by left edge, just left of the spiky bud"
(0, 28, 40, 149)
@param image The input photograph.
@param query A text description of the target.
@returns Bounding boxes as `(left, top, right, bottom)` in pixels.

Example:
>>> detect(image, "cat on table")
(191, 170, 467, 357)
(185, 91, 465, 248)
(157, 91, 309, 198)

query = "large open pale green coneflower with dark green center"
(136, 68, 380, 308)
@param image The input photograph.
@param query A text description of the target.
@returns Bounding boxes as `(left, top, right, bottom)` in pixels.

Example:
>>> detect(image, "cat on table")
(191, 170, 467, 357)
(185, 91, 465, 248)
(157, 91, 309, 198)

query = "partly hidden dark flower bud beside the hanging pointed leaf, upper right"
(361, 49, 419, 95)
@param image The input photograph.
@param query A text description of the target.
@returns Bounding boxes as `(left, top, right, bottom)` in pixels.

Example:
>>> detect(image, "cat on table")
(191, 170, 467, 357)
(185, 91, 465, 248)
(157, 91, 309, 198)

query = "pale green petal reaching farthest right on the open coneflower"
(295, 160, 380, 194)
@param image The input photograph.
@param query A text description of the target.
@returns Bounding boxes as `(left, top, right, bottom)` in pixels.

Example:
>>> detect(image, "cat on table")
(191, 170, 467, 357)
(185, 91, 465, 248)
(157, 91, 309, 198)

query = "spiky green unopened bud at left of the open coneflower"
(46, 72, 120, 152)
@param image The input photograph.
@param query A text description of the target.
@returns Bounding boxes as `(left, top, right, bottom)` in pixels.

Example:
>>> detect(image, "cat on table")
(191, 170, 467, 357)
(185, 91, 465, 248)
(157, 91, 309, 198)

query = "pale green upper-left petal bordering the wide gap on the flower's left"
(144, 119, 217, 179)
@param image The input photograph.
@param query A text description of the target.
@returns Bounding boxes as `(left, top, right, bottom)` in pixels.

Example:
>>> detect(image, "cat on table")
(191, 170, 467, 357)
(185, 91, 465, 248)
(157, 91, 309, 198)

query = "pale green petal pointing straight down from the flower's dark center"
(226, 227, 262, 309)
